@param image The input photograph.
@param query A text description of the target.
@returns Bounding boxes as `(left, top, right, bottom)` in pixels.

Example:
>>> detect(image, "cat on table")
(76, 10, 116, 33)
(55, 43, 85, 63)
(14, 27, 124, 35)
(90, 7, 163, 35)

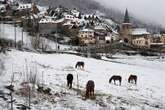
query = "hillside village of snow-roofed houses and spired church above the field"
(0, 0, 165, 53)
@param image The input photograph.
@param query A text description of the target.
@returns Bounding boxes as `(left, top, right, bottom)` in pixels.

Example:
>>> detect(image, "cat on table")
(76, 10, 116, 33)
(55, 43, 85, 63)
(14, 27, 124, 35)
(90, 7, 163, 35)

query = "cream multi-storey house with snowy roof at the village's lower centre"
(78, 28, 96, 45)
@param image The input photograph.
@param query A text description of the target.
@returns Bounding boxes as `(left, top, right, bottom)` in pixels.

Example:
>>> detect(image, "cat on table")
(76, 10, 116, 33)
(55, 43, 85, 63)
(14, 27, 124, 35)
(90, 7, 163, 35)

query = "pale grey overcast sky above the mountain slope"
(96, 0, 165, 27)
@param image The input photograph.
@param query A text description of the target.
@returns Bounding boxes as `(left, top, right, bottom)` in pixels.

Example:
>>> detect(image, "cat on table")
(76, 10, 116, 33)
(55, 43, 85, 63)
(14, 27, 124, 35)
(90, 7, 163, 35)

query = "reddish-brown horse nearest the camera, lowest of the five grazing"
(85, 80, 95, 98)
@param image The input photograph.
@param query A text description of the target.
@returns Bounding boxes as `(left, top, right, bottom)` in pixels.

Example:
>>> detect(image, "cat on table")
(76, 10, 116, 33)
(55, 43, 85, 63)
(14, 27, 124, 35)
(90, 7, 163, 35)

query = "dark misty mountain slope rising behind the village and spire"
(21, 0, 163, 33)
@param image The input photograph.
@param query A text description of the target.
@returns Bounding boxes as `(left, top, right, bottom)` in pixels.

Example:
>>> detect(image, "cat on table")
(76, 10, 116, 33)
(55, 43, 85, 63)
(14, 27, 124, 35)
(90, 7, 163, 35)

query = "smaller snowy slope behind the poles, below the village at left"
(0, 24, 70, 51)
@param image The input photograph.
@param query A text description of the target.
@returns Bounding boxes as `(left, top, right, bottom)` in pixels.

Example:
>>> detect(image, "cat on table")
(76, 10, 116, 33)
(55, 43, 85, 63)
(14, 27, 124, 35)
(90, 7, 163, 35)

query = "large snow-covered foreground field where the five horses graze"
(0, 50, 165, 110)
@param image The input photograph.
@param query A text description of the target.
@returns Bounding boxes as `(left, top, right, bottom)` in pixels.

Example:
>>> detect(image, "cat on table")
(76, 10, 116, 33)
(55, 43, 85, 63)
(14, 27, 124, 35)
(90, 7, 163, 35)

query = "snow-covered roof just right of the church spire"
(132, 28, 150, 35)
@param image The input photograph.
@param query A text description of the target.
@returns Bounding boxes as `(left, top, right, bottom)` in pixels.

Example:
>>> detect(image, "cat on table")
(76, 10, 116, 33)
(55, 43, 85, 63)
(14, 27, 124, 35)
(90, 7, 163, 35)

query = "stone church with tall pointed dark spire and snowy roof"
(119, 9, 151, 47)
